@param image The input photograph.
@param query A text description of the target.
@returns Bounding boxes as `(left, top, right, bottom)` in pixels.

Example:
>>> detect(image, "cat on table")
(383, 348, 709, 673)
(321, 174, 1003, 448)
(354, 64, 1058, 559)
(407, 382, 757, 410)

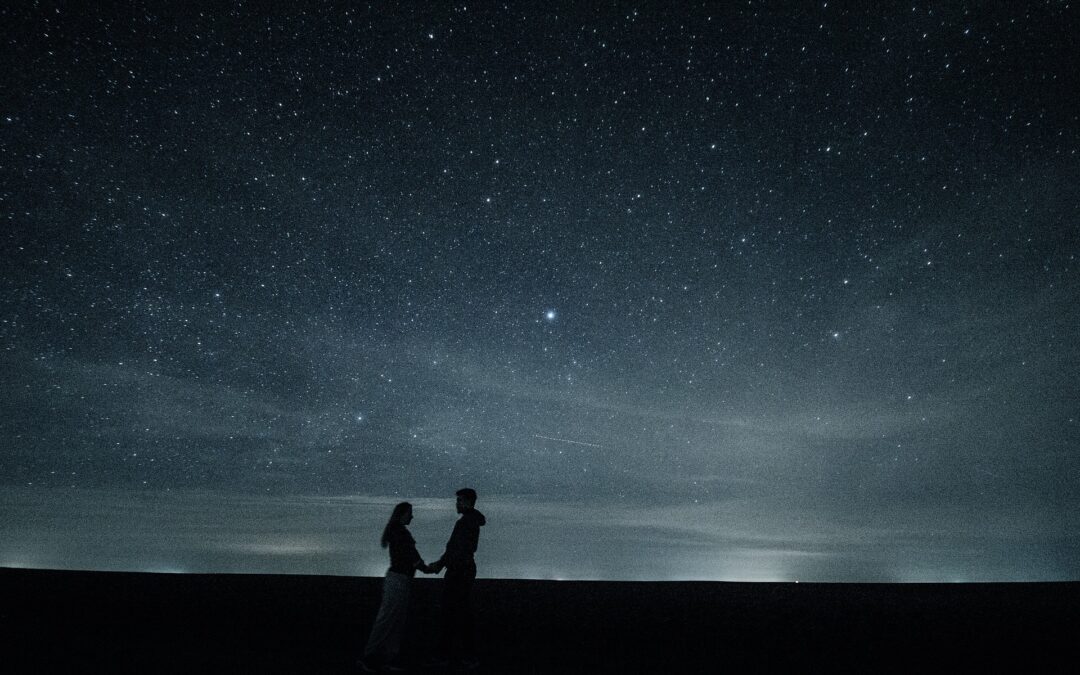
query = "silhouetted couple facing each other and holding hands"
(359, 487, 486, 673)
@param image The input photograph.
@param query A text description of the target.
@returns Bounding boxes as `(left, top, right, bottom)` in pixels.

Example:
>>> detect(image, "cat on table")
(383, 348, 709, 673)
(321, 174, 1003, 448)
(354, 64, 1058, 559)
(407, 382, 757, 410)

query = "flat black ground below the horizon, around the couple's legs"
(0, 569, 1080, 674)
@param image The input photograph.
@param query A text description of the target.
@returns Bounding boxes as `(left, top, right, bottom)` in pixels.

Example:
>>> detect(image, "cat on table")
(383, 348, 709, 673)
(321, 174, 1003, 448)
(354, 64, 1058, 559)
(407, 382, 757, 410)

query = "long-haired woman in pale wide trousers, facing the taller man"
(359, 501, 429, 673)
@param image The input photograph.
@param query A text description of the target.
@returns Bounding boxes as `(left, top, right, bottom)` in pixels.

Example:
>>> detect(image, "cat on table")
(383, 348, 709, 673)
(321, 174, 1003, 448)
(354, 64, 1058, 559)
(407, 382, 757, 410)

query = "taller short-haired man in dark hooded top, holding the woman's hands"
(429, 487, 487, 669)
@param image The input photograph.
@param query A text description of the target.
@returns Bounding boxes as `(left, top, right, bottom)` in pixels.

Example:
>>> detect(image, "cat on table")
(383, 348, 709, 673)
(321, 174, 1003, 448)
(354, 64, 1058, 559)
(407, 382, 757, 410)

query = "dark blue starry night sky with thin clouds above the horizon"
(0, 0, 1080, 581)
